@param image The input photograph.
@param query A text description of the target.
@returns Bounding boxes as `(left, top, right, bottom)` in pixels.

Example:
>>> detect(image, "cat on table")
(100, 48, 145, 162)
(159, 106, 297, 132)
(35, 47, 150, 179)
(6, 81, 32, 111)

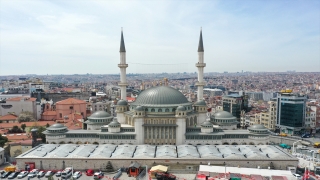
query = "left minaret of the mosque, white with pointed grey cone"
(118, 28, 128, 101)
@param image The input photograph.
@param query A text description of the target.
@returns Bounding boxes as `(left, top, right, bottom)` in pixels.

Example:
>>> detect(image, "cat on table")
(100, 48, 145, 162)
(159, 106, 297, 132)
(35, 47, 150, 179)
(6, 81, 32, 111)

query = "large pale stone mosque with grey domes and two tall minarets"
(44, 31, 269, 145)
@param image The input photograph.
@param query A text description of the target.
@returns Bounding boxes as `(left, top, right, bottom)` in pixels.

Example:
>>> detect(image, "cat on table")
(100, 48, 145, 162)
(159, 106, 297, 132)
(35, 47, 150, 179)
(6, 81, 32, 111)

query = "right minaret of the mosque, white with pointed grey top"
(195, 29, 206, 101)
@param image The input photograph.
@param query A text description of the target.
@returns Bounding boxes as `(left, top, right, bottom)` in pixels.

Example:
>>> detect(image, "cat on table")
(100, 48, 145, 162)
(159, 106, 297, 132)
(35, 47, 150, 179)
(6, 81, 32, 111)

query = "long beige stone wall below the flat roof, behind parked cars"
(17, 158, 298, 170)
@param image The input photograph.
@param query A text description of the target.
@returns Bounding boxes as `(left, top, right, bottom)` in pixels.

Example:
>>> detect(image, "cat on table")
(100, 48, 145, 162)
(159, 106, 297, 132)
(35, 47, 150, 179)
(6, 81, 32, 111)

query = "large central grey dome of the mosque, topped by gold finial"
(132, 86, 189, 105)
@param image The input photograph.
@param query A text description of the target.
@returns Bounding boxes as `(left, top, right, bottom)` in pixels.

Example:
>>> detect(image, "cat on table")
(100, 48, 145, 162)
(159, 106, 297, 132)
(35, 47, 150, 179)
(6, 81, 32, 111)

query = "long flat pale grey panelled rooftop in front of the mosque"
(17, 144, 296, 160)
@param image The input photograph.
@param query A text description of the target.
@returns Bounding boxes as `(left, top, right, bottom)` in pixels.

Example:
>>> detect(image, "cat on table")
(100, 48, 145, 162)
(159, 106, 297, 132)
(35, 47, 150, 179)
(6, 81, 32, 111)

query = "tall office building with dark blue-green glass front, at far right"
(277, 92, 307, 135)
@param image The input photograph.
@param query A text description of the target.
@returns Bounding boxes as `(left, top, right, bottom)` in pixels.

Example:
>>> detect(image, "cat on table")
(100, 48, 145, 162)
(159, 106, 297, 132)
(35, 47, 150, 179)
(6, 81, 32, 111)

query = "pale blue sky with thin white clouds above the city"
(0, 0, 320, 76)
